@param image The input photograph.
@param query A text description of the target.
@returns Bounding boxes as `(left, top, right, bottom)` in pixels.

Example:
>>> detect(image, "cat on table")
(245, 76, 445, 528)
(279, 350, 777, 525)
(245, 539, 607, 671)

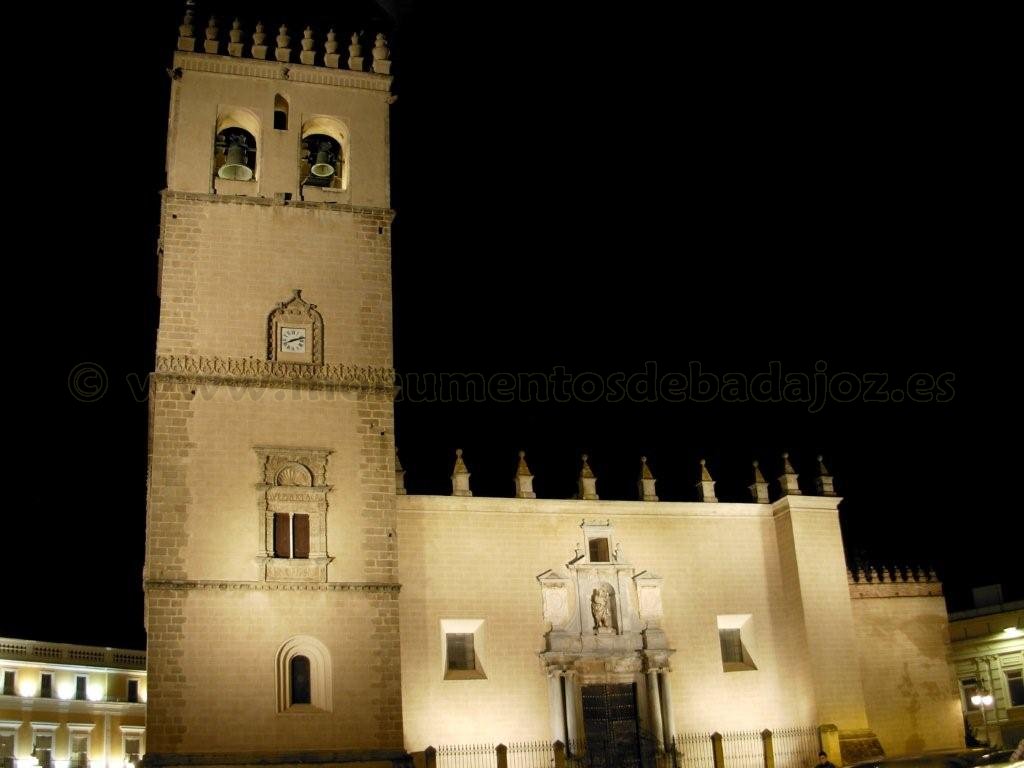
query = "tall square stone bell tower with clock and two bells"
(143, 15, 402, 765)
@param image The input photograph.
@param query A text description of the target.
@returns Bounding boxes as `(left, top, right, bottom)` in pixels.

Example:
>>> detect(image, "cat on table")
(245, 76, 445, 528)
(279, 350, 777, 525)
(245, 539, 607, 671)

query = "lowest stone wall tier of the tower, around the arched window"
(146, 587, 401, 753)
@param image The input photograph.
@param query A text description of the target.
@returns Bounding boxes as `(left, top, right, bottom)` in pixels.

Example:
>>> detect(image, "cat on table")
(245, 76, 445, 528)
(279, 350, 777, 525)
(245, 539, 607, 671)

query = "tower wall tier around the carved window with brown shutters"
(147, 381, 397, 582)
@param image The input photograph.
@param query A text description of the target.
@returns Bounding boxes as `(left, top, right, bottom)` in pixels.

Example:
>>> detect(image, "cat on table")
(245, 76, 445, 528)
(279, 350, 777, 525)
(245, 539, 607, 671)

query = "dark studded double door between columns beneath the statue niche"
(581, 683, 642, 768)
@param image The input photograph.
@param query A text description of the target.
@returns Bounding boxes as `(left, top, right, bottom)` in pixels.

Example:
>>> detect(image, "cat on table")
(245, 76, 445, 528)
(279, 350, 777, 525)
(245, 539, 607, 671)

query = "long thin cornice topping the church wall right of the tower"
(395, 496, 771, 518)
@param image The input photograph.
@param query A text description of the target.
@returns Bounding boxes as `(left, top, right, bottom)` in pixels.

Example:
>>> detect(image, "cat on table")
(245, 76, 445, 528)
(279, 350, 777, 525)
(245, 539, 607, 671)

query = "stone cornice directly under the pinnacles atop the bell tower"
(174, 51, 391, 94)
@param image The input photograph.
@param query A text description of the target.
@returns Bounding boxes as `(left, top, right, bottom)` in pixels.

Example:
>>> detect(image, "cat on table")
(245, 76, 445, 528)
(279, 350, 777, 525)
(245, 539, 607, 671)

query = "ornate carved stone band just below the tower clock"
(155, 354, 394, 394)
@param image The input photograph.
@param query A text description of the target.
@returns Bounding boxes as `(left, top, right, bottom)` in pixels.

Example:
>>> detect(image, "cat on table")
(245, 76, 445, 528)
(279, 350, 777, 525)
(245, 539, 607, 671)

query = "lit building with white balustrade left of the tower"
(0, 637, 146, 768)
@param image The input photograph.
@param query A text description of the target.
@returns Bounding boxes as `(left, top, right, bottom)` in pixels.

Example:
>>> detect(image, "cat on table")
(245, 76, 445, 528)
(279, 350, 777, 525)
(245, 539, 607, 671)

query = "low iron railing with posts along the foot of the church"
(415, 725, 821, 768)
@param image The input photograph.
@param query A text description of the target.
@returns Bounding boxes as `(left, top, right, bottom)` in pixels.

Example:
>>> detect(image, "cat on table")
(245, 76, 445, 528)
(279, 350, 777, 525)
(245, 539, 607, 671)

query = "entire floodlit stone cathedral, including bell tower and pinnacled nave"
(143, 15, 964, 768)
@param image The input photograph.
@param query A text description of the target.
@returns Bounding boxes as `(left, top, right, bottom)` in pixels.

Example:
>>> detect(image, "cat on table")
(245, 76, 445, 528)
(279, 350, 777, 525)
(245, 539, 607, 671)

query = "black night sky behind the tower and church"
(8, 0, 1024, 648)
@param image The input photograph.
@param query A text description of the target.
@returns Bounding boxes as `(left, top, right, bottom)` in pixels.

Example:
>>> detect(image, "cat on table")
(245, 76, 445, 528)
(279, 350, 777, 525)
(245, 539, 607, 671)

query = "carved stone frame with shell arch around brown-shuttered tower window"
(253, 445, 334, 584)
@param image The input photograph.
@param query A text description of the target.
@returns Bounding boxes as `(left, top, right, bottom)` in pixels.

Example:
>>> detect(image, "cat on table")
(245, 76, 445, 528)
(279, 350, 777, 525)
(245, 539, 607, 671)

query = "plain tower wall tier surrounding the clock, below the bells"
(157, 193, 391, 368)
